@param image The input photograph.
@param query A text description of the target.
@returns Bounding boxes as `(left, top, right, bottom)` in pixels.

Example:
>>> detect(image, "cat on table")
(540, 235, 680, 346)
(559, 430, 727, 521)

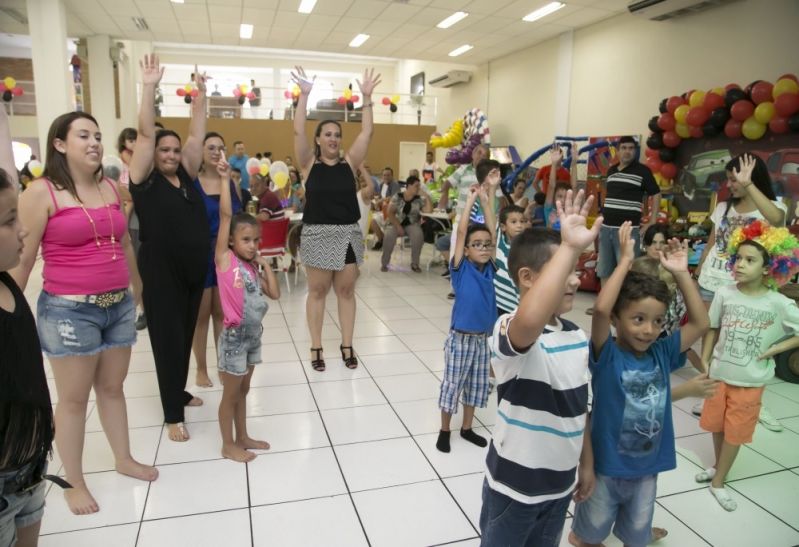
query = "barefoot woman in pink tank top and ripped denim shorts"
(11, 112, 158, 515)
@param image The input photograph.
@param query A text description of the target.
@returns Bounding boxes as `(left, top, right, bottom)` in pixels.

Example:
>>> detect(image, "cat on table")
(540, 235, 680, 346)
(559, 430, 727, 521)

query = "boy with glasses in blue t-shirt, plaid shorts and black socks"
(436, 160, 500, 452)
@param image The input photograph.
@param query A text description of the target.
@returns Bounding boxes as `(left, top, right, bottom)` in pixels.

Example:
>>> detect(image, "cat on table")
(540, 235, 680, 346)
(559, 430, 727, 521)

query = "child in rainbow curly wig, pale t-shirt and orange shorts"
(696, 220, 799, 511)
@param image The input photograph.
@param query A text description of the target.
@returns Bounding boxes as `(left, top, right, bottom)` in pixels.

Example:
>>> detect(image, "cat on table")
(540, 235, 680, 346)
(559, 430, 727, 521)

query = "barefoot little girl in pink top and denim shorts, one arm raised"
(214, 153, 280, 462)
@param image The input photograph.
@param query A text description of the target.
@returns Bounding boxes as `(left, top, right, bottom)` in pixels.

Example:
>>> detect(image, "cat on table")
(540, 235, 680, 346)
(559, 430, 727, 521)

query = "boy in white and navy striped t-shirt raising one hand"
(480, 191, 602, 547)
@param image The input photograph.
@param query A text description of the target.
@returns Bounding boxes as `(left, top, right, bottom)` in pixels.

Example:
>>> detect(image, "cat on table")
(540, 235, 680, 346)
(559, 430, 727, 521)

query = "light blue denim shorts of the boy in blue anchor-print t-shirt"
(572, 473, 657, 547)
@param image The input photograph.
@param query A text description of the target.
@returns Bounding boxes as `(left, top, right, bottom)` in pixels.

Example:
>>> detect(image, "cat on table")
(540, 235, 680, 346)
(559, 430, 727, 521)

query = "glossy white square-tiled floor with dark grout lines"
(27, 248, 799, 547)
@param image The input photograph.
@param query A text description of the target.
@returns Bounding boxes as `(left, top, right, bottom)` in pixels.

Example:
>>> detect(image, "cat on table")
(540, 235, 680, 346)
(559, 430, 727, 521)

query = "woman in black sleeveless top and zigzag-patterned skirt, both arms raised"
(291, 67, 380, 372)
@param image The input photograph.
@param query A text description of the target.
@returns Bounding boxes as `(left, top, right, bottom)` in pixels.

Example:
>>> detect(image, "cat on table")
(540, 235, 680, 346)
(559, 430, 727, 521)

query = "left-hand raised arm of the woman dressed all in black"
(128, 53, 164, 184)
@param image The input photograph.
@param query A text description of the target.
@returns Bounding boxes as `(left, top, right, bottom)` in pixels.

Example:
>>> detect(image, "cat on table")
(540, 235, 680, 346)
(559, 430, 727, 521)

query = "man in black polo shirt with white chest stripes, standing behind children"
(596, 136, 660, 286)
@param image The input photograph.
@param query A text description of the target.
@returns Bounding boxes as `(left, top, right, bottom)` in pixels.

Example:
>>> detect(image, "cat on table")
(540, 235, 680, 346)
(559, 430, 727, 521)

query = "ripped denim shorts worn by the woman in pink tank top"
(36, 291, 136, 357)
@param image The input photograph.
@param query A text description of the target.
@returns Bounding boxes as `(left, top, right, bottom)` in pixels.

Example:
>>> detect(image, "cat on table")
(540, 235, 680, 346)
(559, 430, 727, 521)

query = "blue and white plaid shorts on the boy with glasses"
(438, 330, 491, 414)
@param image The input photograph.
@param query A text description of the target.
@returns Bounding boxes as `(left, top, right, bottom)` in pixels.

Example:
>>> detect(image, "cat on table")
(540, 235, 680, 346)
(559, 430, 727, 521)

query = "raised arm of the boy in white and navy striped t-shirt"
(508, 190, 602, 349)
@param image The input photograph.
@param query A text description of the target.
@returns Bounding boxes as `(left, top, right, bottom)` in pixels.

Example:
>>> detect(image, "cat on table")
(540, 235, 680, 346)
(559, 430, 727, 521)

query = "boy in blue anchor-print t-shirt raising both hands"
(569, 222, 710, 547)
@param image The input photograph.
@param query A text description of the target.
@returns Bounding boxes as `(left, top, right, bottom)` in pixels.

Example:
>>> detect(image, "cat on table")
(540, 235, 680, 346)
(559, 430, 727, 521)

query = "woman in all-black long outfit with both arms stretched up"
(130, 54, 211, 441)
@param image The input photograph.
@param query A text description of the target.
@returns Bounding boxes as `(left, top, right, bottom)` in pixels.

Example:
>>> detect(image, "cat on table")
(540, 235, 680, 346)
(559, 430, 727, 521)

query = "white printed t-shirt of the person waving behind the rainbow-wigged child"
(699, 201, 788, 292)
